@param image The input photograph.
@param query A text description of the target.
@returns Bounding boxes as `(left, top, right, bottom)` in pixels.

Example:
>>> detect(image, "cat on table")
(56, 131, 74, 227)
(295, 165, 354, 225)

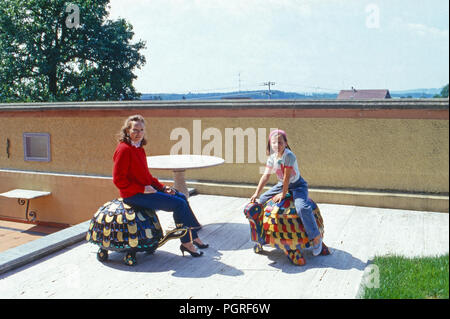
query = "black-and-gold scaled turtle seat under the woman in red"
(86, 198, 189, 266)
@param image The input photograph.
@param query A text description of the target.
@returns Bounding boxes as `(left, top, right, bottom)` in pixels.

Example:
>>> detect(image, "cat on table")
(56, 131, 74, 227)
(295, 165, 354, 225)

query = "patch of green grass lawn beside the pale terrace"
(361, 254, 449, 299)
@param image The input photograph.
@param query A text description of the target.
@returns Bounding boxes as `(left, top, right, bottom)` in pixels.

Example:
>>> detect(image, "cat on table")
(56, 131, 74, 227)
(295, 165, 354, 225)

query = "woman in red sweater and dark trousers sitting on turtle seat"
(113, 115, 208, 257)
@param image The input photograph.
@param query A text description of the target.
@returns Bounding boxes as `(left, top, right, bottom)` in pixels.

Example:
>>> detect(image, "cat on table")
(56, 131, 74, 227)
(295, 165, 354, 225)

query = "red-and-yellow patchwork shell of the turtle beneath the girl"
(262, 197, 324, 251)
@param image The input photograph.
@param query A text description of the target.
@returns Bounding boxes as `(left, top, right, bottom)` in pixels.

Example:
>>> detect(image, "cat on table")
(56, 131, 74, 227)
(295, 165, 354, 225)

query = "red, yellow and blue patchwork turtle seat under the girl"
(244, 194, 330, 266)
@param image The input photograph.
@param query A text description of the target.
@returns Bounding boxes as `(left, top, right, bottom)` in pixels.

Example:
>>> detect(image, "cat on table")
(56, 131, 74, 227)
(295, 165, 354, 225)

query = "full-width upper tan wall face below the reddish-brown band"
(0, 114, 449, 193)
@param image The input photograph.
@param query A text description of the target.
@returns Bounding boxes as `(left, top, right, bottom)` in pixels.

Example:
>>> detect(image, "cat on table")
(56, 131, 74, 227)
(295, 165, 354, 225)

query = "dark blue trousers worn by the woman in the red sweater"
(123, 191, 200, 243)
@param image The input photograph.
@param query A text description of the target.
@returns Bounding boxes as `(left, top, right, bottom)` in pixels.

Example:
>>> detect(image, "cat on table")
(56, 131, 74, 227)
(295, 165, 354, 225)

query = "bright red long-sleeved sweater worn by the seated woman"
(113, 142, 164, 198)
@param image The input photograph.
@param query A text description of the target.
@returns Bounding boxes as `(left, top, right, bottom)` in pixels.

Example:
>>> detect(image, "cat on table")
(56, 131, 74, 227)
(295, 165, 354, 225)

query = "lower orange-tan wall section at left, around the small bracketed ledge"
(0, 171, 118, 225)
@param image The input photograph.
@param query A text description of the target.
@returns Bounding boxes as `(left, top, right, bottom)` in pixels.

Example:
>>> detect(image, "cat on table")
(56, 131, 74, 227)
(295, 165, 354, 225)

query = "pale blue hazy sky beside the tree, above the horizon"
(110, 0, 449, 93)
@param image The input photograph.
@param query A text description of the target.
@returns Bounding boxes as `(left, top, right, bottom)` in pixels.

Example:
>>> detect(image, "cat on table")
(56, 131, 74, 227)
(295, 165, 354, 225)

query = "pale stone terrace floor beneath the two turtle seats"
(0, 195, 449, 299)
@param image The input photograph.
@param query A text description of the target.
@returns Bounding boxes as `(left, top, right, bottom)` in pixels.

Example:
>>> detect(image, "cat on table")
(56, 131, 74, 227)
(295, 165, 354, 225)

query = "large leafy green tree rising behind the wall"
(0, 0, 145, 102)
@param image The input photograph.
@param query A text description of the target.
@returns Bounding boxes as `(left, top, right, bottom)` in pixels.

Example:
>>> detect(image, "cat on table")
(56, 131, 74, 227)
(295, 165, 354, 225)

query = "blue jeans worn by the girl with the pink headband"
(259, 176, 320, 239)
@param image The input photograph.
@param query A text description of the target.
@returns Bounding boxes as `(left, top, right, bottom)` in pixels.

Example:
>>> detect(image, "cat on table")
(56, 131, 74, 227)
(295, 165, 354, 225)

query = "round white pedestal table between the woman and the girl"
(147, 155, 225, 198)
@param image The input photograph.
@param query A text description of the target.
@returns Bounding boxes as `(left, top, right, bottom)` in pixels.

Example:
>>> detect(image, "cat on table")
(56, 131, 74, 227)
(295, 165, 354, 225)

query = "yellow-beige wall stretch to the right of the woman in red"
(147, 118, 449, 193)
